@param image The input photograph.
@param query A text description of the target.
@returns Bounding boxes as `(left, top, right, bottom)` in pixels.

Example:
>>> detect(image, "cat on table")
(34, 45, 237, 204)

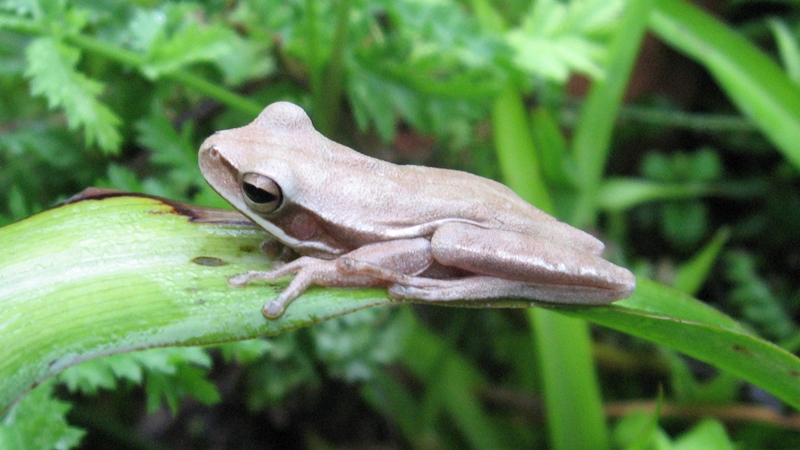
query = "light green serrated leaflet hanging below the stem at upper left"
(25, 37, 122, 153)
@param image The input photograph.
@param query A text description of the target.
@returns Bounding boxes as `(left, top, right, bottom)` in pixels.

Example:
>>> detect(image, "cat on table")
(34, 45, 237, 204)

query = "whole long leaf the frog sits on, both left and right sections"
(0, 192, 800, 411)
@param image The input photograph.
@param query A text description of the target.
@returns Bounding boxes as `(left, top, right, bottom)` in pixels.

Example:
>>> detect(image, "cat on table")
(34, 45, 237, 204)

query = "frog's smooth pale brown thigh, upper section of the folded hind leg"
(431, 223, 635, 303)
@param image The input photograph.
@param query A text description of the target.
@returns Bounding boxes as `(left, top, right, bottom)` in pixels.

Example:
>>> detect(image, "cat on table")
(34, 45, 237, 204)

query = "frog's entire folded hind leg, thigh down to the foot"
(384, 223, 636, 305)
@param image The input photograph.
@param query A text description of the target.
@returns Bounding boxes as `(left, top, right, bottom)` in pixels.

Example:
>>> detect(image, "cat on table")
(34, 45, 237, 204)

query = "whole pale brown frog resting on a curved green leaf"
(199, 102, 635, 318)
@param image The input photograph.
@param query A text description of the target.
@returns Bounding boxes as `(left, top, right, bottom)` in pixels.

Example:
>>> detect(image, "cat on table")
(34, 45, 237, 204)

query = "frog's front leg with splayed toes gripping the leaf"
(228, 238, 433, 319)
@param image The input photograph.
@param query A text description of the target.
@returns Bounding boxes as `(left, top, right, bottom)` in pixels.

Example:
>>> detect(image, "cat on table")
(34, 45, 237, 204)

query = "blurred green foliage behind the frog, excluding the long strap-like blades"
(0, 0, 800, 449)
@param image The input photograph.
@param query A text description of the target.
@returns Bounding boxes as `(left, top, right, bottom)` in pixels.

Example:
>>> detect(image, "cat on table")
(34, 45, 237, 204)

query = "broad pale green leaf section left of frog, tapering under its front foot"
(0, 192, 389, 412)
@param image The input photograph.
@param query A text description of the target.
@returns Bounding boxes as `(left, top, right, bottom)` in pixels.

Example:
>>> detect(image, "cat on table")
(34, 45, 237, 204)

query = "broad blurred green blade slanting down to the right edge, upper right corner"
(650, 0, 800, 168)
